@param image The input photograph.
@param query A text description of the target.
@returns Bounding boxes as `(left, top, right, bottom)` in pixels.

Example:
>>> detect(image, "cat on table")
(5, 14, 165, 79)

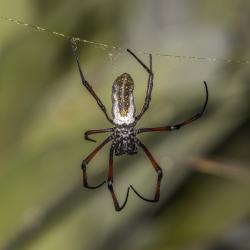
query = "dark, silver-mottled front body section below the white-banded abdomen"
(113, 126, 138, 155)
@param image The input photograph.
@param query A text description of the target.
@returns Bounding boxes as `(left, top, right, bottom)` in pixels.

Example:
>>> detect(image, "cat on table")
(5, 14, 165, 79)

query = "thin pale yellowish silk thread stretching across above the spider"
(0, 16, 250, 64)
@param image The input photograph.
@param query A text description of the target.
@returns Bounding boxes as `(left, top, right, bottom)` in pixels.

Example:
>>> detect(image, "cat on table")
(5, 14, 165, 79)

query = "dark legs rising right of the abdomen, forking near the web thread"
(127, 49, 154, 121)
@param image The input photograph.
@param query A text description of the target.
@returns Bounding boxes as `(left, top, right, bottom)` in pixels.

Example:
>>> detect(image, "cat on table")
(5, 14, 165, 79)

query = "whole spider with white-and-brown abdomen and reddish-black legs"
(71, 39, 208, 211)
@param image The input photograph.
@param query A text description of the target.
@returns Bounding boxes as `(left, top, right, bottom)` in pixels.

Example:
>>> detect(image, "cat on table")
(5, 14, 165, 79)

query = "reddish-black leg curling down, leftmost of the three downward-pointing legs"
(82, 136, 112, 189)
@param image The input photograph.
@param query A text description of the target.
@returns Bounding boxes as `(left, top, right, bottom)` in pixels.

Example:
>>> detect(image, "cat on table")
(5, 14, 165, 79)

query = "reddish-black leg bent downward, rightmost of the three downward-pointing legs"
(130, 139, 163, 202)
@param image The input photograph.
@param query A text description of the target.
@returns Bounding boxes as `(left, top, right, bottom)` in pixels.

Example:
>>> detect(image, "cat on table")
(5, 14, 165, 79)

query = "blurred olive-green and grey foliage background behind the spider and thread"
(0, 0, 250, 250)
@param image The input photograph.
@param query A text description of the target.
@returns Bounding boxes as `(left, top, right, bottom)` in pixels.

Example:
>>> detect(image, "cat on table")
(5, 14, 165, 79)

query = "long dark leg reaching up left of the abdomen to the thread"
(70, 38, 114, 124)
